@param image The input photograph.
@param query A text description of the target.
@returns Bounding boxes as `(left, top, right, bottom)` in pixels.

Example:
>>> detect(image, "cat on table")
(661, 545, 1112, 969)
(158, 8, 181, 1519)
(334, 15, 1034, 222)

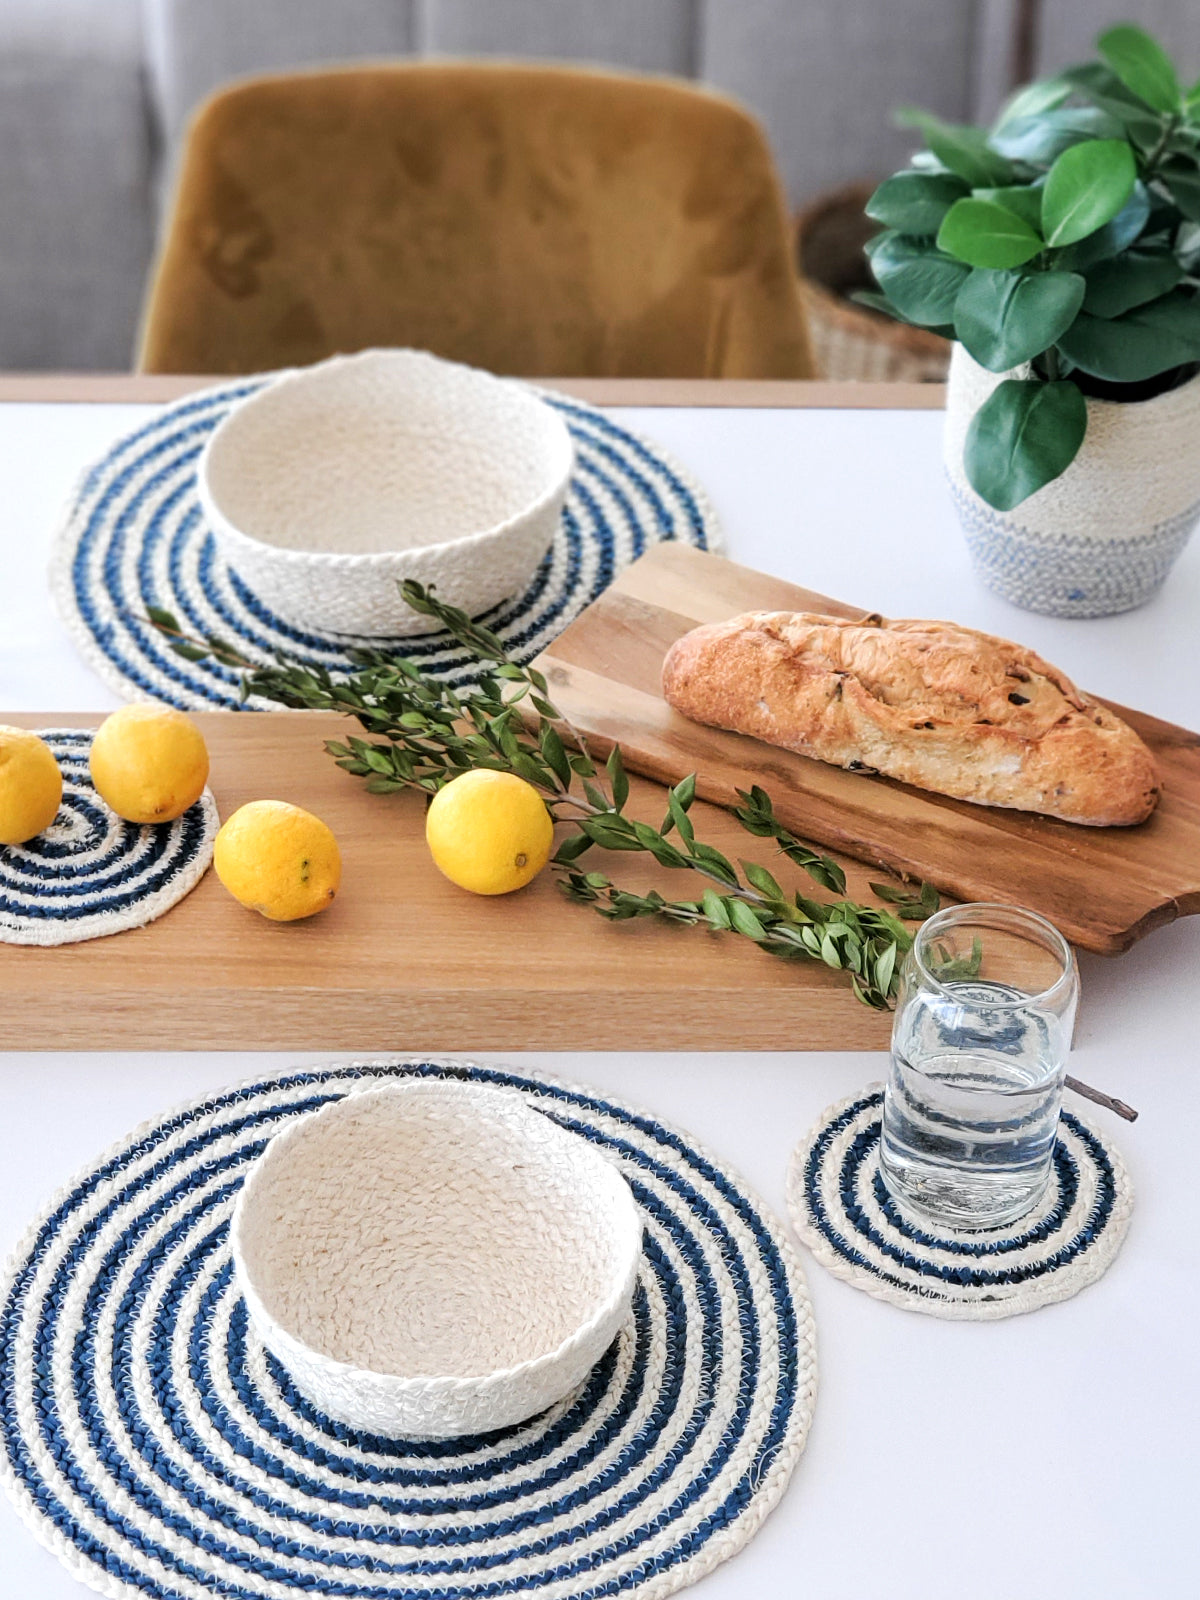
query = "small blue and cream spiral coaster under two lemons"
(0, 728, 221, 944)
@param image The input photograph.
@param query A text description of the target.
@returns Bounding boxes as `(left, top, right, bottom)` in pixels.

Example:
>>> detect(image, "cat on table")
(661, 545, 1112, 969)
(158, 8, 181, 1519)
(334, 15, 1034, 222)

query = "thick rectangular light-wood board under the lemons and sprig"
(0, 712, 891, 1053)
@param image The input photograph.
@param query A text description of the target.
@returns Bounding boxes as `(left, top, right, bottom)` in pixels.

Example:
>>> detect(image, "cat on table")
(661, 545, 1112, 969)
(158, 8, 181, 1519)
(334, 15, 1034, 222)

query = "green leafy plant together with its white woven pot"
(867, 26, 1200, 616)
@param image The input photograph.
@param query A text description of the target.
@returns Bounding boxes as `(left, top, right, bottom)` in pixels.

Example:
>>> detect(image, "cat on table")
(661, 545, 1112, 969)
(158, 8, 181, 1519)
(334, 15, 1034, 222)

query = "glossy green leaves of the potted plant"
(859, 24, 1200, 510)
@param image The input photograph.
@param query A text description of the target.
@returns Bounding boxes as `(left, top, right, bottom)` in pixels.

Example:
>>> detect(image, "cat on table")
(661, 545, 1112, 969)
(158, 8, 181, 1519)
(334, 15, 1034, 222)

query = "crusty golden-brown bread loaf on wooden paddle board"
(662, 611, 1158, 827)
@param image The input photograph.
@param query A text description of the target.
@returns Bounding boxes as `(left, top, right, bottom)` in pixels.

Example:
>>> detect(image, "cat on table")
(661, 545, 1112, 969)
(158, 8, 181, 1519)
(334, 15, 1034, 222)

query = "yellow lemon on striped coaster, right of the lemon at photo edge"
(88, 706, 208, 822)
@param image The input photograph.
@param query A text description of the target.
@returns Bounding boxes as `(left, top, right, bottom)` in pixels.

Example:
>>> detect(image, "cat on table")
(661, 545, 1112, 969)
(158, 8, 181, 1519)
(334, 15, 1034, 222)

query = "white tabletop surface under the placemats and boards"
(0, 403, 1200, 1600)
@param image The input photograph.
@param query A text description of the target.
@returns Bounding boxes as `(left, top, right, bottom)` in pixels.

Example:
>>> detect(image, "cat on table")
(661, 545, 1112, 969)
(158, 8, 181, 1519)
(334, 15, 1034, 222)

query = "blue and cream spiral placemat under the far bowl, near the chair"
(50, 378, 720, 710)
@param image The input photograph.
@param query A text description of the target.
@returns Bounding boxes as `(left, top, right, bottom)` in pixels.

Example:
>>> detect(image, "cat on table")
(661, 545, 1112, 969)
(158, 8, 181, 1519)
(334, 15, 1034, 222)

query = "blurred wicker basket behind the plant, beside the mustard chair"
(795, 184, 950, 382)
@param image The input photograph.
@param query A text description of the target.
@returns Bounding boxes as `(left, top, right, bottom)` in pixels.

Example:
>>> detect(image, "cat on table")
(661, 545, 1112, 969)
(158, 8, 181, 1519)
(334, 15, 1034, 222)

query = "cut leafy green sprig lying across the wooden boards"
(150, 582, 938, 1010)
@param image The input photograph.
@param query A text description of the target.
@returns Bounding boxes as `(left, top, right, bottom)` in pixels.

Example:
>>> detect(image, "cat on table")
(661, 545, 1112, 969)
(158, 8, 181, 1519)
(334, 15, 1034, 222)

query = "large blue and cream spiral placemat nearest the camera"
(0, 1061, 816, 1600)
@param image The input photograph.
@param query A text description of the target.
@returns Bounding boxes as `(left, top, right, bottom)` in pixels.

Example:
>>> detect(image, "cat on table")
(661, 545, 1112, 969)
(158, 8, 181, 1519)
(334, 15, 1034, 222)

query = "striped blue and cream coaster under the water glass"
(787, 1088, 1133, 1322)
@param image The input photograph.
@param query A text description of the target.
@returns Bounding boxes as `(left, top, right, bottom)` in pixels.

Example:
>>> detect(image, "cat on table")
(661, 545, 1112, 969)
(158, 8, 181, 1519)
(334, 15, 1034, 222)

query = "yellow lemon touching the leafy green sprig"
(426, 768, 554, 894)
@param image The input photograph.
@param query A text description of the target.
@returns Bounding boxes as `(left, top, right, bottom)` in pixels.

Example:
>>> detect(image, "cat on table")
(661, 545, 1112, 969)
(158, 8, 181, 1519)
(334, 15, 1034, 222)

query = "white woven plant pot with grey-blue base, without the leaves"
(944, 344, 1200, 616)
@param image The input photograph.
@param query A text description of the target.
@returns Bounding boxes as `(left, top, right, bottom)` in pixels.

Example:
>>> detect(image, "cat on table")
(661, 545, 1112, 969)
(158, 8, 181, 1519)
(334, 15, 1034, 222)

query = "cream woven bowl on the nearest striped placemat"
(232, 1078, 642, 1438)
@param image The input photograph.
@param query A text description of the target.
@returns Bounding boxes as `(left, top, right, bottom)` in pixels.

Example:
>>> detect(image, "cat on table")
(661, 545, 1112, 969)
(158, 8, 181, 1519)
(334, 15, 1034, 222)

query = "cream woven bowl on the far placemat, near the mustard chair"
(197, 350, 574, 637)
